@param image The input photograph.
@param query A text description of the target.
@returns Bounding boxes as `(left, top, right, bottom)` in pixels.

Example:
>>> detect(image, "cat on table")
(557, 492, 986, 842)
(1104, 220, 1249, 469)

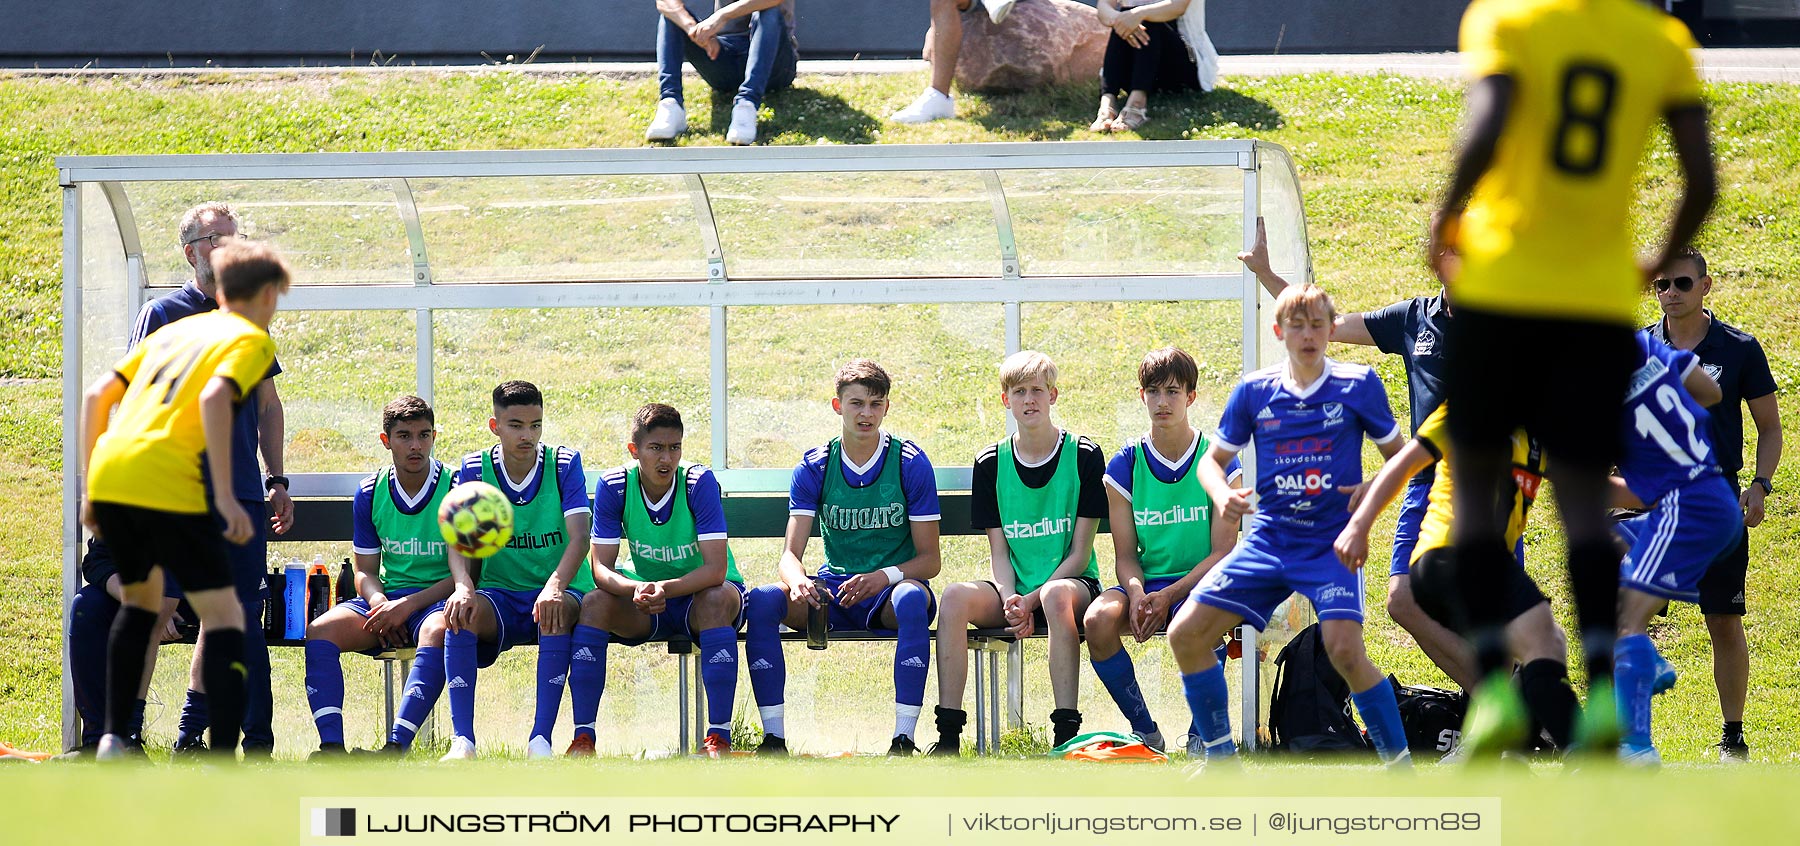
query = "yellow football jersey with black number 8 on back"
(1451, 0, 1701, 326)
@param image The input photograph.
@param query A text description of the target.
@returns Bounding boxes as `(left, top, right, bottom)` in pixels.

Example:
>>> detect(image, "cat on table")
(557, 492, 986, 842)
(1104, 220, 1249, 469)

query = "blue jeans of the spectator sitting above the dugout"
(657, 7, 799, 106)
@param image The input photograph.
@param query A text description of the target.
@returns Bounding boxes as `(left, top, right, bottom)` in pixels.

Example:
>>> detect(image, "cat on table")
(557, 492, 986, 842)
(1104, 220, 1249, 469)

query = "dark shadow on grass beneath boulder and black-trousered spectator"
(970, 85, 1283, 140)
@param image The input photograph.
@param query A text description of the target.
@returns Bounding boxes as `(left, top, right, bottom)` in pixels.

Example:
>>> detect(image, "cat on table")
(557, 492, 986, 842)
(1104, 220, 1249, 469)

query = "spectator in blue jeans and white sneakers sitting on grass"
(644, 0, 799, 144)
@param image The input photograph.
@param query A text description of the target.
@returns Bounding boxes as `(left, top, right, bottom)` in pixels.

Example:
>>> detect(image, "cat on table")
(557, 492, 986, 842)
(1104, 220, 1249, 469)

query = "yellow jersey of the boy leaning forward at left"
(88, 311, 275, 515)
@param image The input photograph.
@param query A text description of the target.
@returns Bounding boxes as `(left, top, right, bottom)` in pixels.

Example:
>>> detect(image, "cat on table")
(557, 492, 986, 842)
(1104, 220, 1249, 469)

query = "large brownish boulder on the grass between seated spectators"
(925, 0, 1111, 92)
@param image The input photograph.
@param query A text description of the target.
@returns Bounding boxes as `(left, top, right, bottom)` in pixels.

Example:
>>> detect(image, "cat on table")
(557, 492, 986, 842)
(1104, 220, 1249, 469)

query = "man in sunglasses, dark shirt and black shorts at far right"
(1645, 248, 1782, 761)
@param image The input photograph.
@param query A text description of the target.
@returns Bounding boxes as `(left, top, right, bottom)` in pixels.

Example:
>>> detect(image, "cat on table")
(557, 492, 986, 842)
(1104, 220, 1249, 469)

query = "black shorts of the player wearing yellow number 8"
(1444, 308, 1638, 473)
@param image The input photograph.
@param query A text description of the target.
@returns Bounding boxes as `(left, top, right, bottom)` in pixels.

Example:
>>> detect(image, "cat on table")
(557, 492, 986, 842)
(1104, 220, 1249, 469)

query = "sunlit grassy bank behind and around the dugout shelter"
(0, 64, 1800, 784)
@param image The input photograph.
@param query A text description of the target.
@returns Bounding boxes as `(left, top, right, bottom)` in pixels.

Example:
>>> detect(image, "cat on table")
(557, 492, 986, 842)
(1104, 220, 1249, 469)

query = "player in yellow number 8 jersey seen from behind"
(1429, 0, 1715, 754)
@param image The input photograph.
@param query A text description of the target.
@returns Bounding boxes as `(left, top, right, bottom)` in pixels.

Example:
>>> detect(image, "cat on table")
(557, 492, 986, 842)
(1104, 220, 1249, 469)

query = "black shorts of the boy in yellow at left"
(94, 502, 232, 594)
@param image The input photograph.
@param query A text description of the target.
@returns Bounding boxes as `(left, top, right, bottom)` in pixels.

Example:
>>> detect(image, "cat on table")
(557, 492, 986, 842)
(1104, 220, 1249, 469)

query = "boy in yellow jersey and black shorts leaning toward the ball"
(81, 243, 290, 760)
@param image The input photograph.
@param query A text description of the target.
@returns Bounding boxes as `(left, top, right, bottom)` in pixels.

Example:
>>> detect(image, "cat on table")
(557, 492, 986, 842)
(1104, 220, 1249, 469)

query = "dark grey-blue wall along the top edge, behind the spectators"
(0, 0, 1467, 67)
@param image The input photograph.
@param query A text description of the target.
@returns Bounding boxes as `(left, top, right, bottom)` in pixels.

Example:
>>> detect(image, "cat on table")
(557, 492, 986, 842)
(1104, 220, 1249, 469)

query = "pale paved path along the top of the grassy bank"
(0, 47, 1800, 83)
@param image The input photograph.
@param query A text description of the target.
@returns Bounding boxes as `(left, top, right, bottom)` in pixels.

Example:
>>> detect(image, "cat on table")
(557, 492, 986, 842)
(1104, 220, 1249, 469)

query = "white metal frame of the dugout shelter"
(56, 140, 1312, 751)
